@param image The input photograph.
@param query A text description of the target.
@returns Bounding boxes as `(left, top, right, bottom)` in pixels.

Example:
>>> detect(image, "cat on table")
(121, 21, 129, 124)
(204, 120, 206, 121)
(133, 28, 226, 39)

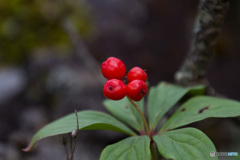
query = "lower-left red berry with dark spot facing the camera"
(103, 79, 127, 100)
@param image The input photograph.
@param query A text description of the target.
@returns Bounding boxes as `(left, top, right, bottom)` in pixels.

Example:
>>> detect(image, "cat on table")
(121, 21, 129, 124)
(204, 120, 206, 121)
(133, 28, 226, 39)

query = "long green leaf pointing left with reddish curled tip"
(23, 111, 136, 151)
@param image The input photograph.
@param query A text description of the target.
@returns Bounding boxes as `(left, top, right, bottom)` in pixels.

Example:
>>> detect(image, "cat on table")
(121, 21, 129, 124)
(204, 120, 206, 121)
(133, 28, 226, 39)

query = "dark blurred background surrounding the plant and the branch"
(0, 0, 240, 160)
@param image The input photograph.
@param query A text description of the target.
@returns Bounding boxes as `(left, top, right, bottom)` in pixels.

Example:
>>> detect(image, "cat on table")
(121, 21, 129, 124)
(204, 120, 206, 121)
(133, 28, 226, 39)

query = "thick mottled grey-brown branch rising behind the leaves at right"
(175, 0, 229, 92)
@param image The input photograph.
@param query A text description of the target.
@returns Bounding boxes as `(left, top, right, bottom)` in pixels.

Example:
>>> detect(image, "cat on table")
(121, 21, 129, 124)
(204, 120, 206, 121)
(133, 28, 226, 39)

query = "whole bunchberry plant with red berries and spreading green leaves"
(23, 57, 240, 160)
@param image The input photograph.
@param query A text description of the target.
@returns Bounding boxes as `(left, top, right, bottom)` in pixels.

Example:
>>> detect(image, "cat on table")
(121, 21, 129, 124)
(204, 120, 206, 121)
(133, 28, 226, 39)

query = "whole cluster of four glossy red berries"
(101, 57, 148, 101)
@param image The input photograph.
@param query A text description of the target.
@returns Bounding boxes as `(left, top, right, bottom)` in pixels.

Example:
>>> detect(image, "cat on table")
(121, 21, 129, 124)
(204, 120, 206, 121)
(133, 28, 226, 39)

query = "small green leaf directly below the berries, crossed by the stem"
(103, 97, 144, 131)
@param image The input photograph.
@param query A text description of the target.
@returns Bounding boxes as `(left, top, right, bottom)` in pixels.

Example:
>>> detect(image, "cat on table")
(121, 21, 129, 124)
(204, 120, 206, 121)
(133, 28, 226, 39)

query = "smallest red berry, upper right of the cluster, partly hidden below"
(127, 67, 148, 82)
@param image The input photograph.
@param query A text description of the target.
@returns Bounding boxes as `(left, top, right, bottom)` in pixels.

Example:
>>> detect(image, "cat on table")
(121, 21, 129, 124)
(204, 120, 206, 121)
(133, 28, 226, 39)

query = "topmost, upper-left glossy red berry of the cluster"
(101, 57, 126, 79)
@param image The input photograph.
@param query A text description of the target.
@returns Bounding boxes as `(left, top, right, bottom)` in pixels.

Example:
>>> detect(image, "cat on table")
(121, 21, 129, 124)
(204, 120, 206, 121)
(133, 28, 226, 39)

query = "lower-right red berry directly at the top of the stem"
(127, 80, 148, 101)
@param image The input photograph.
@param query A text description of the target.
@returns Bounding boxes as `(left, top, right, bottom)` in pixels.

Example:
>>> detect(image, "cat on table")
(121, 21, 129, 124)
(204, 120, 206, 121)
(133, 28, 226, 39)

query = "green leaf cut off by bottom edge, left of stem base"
(100, 136, 151, 160)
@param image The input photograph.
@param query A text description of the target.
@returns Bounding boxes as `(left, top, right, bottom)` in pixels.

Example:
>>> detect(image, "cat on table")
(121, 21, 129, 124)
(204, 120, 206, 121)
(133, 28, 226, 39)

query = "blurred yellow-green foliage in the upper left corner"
(0, 0, 93, 65)
